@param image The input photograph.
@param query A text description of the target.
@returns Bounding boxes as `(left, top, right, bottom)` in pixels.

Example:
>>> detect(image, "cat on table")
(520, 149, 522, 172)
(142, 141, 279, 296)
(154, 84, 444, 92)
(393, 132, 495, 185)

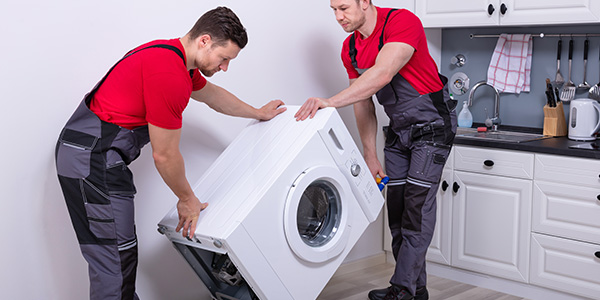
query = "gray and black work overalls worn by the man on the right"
(350, 10, 457, 295)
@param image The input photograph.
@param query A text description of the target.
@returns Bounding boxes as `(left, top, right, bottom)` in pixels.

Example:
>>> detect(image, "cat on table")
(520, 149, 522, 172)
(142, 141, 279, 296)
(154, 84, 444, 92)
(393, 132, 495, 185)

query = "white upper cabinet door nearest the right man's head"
(415, 0, 500, 28)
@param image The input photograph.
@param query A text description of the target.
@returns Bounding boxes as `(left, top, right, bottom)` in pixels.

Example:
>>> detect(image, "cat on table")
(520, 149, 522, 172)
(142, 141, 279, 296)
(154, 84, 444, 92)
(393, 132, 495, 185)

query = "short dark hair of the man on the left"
(188, 6, 248, 49)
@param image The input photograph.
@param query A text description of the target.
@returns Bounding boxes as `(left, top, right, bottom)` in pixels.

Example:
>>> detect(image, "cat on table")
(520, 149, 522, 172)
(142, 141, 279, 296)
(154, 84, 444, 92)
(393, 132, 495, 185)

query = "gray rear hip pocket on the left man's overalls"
(56, 128, 98, 178)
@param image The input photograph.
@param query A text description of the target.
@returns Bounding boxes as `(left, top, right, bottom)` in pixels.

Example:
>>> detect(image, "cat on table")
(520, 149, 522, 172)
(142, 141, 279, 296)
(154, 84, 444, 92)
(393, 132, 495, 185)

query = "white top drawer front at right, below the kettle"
(535, 154, 600, 188)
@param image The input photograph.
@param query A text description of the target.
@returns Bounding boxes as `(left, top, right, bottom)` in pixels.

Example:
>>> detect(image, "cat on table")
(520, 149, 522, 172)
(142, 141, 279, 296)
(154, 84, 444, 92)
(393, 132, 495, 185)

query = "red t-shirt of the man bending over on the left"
(90, 39, 206, 129)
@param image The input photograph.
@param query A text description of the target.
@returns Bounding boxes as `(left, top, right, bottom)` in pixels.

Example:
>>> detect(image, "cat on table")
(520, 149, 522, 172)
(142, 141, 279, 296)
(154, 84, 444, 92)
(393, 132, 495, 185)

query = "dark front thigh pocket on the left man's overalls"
(106, 149, 136, 195)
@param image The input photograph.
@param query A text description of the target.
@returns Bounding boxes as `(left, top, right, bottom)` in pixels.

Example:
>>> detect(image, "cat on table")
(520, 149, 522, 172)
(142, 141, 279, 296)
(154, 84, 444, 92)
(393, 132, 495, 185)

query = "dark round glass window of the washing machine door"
(296, 179, 342, 247)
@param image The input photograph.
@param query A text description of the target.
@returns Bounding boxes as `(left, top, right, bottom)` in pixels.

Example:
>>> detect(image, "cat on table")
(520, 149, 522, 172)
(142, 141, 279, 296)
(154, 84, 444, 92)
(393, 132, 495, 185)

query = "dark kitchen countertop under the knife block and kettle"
(454, 126, 600, 159)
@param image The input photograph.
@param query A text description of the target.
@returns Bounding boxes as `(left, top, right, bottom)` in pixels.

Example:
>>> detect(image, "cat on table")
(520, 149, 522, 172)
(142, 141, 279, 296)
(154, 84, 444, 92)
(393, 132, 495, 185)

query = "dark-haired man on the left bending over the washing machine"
(56, 7, 285, 300)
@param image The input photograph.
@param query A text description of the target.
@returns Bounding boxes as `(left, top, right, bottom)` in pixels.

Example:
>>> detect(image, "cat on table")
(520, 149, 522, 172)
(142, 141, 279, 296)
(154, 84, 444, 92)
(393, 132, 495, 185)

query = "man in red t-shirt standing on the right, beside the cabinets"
(295, 0, 457, 300)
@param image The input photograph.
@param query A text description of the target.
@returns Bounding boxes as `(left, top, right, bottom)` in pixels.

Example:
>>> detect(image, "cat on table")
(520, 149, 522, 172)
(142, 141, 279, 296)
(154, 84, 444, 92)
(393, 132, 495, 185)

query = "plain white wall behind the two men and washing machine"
(0, 0, 412, 299)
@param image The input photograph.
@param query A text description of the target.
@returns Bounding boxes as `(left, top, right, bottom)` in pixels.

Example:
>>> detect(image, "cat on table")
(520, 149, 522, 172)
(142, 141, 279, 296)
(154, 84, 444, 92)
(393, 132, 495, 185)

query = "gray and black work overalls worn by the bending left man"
(55, 45, 192, 300)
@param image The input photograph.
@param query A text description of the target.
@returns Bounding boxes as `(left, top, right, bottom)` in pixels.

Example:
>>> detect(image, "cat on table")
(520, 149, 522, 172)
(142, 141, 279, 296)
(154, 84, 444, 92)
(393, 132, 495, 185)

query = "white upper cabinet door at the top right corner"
(499, 0, 600, 25)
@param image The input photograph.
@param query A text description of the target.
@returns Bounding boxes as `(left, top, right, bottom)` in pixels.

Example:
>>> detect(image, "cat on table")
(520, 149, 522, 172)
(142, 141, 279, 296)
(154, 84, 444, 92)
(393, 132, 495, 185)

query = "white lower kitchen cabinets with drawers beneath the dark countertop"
(427, 145, 600, 299)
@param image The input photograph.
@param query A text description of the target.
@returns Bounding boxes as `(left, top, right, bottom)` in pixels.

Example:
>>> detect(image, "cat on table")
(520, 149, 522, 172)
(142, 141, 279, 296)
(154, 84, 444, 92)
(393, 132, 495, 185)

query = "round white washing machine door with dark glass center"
(284, 166, 356, 263)
